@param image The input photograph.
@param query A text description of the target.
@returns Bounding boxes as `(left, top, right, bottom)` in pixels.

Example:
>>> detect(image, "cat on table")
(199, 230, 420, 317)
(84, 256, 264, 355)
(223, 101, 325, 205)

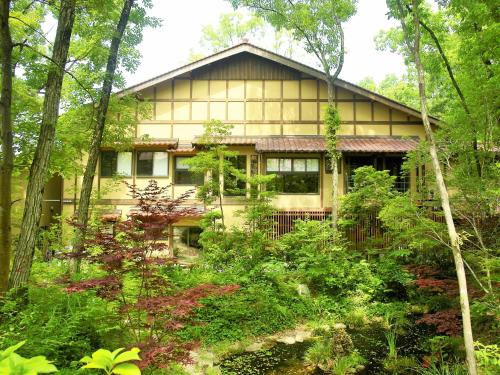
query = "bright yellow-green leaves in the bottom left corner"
(0, 341, 57, 375)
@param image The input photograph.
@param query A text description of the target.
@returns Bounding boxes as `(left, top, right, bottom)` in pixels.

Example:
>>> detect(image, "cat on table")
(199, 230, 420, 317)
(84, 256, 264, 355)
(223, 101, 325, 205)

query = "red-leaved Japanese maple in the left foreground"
(66, 181, 238, 367)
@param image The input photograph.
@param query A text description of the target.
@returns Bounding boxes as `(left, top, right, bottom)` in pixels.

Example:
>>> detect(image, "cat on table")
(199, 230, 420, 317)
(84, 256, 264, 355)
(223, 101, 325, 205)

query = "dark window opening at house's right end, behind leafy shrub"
(346, 156, 410, 192)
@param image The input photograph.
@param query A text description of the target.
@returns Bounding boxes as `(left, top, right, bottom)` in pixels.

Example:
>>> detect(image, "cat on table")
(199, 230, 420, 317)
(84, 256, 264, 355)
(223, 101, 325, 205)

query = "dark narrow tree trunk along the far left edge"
(0, 0, 14, 295)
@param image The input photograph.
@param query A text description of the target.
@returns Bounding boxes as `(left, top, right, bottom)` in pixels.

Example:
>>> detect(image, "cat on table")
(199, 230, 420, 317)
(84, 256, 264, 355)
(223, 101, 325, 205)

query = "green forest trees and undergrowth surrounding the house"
(0, 0, 500, 375)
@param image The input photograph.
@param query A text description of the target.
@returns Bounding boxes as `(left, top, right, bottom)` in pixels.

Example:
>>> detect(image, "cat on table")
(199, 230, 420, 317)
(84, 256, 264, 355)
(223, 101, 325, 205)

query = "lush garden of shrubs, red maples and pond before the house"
(0, 167, 499, 374)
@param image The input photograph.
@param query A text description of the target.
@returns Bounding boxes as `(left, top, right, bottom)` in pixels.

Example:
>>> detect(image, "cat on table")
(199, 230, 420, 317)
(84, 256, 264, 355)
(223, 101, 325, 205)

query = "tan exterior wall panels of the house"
(58, 73, 424, 232)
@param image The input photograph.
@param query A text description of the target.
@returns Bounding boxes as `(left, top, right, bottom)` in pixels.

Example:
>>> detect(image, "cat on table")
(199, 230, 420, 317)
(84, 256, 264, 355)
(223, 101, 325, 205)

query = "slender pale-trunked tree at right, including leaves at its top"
(387, 0, 477, 375)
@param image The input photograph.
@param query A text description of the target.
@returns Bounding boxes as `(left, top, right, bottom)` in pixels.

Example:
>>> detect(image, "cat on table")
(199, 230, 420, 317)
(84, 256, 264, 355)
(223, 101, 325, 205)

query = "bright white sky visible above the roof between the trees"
(122, 0, 406, 86)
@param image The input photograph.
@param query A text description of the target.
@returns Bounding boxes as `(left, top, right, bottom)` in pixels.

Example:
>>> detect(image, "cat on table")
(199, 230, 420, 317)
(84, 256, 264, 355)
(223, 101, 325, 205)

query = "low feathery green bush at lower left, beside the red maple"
(0, 287, 120, 367)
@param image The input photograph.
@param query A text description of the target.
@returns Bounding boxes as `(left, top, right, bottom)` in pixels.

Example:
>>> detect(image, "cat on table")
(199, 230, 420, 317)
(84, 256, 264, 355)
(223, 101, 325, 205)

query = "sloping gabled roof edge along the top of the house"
(118, 42, 439, 124)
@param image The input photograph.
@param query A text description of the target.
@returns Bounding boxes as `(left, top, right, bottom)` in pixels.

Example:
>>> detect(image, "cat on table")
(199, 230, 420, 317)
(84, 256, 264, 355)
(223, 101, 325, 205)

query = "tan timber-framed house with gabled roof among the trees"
(55, 43, 437, 254)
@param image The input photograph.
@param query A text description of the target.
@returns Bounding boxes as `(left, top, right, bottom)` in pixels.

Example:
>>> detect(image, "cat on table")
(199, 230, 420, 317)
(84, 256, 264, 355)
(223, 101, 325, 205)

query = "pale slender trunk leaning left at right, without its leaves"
(408, 0, 477, 375)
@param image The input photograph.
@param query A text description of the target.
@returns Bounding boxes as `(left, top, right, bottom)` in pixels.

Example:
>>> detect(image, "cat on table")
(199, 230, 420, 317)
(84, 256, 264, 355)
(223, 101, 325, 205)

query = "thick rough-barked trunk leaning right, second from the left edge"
(9, 0, 76, 288)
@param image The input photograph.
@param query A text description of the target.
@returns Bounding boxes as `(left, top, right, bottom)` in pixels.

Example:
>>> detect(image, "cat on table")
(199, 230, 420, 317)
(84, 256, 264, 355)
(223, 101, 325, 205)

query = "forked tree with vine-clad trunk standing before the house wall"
(231, 0, 356, 228)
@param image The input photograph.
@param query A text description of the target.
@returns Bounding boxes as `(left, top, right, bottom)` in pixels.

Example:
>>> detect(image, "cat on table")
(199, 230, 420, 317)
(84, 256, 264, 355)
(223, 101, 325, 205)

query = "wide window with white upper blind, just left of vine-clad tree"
(266, 158, 319, 194)
